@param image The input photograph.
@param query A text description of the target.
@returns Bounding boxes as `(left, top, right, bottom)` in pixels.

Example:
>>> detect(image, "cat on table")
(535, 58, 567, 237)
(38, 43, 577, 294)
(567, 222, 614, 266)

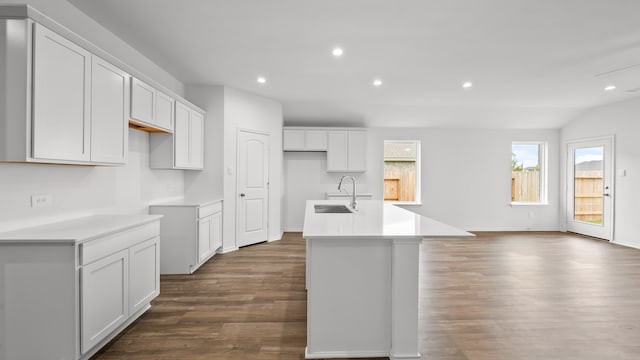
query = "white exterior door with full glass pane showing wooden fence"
(567, 137, 614, 240)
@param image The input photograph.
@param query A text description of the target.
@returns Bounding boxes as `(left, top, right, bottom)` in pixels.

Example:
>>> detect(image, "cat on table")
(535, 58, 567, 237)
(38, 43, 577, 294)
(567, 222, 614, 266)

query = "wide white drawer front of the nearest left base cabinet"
(80, 221, 160, 265)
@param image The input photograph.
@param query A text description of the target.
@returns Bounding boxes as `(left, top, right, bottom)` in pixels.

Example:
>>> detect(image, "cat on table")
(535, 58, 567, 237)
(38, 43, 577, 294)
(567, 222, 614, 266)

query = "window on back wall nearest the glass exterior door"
(511, 141, 547, 204)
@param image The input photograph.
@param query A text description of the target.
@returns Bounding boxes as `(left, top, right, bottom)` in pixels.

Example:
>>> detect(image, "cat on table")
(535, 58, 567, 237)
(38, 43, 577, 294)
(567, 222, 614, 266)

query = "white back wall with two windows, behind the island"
(284, 128, 561, 231)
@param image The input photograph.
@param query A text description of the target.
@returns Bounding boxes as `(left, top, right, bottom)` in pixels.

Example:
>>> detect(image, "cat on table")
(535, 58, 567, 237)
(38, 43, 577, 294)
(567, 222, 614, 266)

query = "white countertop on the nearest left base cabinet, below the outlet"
(0, 214, 162, 244)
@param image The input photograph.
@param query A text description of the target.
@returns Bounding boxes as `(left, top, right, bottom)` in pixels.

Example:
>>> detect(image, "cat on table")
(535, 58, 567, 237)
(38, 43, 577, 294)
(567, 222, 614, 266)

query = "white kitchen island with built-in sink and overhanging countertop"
(303, 200, 474, 359)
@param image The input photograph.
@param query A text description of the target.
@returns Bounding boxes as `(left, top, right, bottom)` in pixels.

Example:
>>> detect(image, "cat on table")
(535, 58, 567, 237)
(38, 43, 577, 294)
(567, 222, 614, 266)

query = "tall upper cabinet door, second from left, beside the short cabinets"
(91, 56, 129, 164)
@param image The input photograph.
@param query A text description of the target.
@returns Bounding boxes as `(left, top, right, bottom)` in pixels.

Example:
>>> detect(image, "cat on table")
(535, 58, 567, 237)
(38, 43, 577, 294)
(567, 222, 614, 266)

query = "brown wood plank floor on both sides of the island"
(93, 233, 640, 360)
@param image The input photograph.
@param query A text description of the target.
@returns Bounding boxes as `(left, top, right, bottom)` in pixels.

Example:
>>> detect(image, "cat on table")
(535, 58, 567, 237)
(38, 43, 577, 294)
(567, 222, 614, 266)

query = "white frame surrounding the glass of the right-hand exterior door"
(563, 135, 616, 242)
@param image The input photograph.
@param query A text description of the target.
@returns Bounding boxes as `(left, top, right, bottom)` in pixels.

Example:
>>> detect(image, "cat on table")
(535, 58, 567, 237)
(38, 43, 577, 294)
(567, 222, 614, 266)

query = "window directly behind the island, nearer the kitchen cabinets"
(384, 140, 420, 204)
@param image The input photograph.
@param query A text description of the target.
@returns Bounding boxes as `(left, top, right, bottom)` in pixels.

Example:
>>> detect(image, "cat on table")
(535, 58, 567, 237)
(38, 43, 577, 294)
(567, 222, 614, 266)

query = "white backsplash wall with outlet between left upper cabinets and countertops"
(0, 129, 184, 232)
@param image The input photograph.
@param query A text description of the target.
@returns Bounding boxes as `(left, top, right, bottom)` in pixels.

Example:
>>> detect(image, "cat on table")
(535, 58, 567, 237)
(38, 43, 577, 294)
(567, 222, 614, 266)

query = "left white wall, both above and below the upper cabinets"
(0, 0, 190, 231)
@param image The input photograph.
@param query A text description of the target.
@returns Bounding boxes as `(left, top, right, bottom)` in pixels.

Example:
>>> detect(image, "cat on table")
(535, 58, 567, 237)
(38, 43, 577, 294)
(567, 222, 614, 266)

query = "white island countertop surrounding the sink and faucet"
(302, 200, 475, 238)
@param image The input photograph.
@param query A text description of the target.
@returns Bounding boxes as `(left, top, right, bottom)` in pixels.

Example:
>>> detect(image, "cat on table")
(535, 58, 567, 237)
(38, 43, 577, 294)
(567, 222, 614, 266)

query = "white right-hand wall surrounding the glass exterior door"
(561, 98, 640, 248)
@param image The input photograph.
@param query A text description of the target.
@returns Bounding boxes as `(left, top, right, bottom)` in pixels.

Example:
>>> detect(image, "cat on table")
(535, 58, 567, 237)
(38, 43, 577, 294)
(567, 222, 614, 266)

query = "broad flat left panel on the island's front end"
(306, 238, 392, 358)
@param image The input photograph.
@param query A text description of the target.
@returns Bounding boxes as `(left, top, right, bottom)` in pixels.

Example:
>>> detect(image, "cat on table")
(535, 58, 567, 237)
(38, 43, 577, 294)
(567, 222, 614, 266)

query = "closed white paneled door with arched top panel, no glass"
(237, 130, 269, 246)
